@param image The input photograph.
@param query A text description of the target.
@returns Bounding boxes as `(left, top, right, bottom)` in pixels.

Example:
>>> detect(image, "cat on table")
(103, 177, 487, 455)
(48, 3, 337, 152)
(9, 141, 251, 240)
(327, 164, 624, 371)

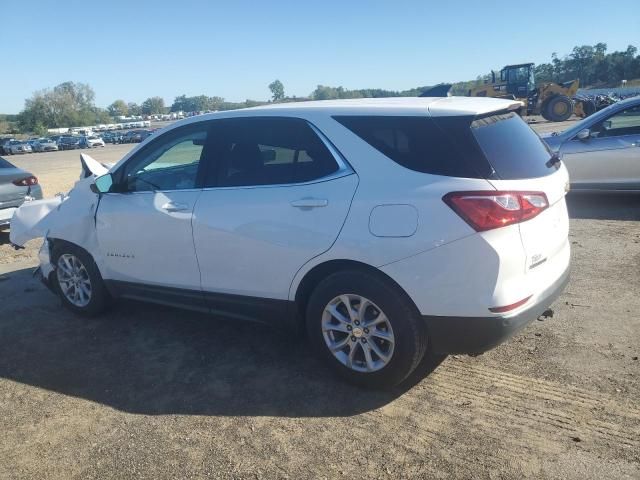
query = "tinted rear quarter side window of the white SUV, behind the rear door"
(334, 116, 491, 178)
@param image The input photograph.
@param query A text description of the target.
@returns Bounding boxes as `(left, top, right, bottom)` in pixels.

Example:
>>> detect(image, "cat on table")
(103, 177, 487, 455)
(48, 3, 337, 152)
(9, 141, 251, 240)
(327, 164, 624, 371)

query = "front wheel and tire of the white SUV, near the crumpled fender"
(50, 242, 110, 317)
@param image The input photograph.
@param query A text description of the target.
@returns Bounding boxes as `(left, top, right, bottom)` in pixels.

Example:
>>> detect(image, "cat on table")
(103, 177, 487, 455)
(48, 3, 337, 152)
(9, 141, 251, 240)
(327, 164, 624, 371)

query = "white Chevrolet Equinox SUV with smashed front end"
(11, 97, 569, 386)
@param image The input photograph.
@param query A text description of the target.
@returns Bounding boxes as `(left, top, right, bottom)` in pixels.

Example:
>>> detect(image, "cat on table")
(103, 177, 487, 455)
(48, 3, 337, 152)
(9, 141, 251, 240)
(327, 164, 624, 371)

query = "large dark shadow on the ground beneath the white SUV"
(0, 269, 445, 417)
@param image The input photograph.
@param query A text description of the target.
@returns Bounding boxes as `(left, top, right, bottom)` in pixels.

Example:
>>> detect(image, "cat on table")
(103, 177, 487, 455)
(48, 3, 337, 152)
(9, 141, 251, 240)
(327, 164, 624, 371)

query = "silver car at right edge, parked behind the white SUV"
(543, 97, 640, 191)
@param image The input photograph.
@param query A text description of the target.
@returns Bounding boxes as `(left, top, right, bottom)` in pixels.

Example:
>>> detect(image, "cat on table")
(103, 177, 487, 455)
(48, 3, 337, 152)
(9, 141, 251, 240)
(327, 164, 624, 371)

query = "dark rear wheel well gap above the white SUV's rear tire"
(295, 260, 419, 321)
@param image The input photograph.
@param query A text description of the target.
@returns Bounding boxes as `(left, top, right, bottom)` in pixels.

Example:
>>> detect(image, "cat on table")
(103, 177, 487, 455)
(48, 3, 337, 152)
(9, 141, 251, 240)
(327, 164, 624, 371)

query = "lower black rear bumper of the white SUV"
(423, 268, 569, 354)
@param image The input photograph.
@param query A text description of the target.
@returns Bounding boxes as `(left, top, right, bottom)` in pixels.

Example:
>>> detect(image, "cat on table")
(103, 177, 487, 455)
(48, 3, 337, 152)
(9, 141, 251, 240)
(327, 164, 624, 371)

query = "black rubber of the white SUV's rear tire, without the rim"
(306, 271, 427, 388)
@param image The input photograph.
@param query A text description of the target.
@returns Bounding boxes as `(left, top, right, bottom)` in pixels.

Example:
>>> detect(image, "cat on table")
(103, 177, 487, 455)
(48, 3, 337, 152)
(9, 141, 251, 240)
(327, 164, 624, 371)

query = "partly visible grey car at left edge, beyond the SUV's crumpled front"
(0, 157, 42, 229)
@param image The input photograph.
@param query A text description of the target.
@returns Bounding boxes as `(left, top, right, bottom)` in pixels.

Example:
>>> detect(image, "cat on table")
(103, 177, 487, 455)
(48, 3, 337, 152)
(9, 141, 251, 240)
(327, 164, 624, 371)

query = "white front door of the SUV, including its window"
(96, 122, 207, 309)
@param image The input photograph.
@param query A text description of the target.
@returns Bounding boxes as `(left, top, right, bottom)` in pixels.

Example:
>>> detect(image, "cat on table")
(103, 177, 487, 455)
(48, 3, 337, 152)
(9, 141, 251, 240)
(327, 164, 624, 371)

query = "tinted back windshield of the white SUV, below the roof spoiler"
(471, 113, 556, 180)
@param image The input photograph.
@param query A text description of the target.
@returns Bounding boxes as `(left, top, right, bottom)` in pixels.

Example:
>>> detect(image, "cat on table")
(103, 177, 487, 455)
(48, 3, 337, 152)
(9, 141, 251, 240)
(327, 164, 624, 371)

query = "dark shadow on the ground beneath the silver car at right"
(567, 191, 640, 220)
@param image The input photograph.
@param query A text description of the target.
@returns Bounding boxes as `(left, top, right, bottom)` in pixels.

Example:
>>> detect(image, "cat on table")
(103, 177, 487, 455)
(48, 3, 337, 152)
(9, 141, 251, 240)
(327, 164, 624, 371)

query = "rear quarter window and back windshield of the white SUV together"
(334, 113, 555, 180)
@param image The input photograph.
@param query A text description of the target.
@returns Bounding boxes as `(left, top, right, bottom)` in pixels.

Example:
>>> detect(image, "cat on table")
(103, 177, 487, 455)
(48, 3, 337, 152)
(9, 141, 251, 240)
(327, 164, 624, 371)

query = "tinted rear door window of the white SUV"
(206, 117, 339, 187)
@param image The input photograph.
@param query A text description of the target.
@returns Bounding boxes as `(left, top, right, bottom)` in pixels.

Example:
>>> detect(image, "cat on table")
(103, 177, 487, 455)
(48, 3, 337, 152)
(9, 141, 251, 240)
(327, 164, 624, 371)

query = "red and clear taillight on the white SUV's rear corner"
(442, 190, 549, 232)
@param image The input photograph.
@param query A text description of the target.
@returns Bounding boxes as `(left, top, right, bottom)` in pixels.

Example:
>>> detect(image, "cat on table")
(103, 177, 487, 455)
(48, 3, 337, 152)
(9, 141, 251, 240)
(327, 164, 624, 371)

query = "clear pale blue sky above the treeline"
(0, 0, 640, 113)
